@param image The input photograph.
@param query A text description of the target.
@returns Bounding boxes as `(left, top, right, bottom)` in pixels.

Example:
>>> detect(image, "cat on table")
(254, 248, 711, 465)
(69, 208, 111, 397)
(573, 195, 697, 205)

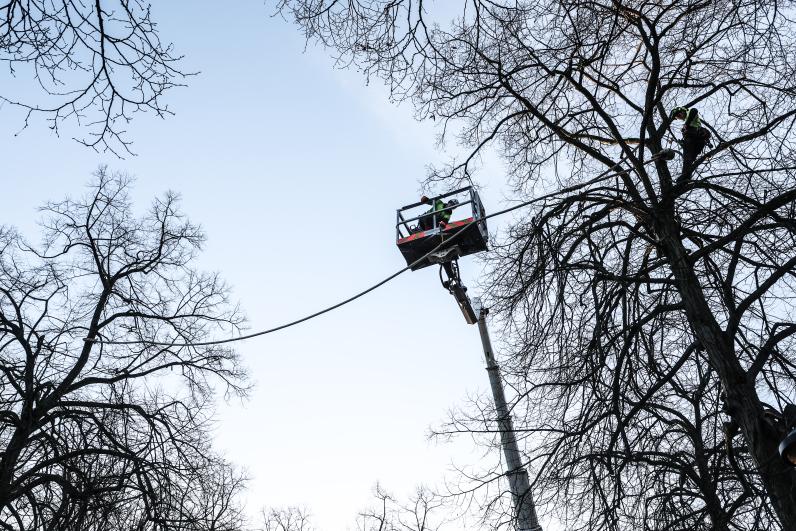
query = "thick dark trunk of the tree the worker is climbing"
(658, 219, 796, 530)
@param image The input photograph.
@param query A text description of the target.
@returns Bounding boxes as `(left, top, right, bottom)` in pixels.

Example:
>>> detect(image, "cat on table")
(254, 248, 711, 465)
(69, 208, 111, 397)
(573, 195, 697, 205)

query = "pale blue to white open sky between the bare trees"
(0, 0, 560, 531)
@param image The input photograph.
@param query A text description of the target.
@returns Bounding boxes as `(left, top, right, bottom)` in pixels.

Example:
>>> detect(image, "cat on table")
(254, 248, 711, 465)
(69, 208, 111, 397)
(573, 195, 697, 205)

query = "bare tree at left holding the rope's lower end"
(0, 168, 247, 531)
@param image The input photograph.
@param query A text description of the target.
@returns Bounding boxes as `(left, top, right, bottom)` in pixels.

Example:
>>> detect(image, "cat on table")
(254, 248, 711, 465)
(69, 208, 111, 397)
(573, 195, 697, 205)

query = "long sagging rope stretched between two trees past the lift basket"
(83, 155, 671, 347)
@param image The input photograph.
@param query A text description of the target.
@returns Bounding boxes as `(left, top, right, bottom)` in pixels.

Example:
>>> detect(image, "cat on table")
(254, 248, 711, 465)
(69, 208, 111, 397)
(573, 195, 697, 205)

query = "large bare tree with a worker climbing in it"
(280, 0, 796, 529)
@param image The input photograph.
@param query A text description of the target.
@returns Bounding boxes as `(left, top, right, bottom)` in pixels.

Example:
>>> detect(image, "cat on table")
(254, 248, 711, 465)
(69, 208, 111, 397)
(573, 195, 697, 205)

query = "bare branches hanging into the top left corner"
(0, 0, 186, 153)
